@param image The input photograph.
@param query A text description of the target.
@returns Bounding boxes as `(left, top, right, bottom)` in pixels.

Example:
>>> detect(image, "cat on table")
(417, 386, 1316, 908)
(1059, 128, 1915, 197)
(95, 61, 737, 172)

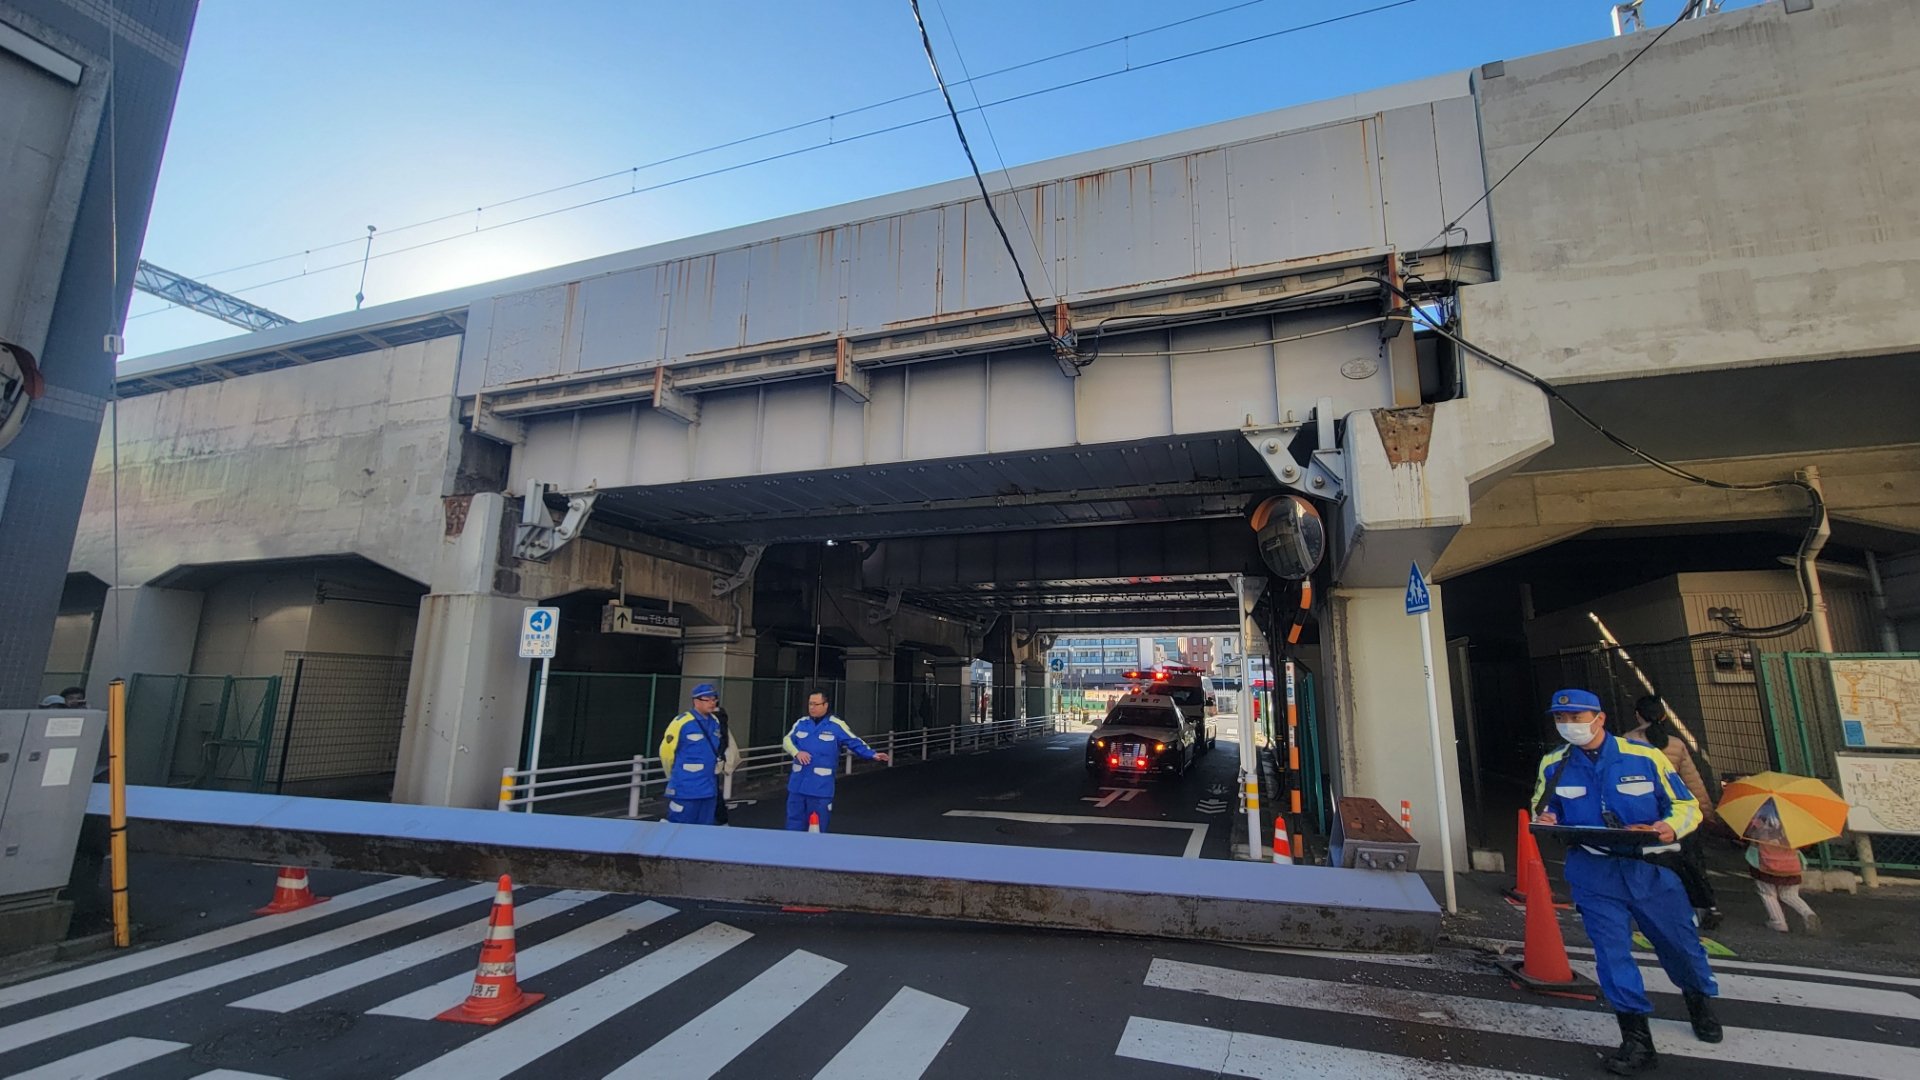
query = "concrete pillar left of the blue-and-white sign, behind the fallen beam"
(394, 492, 532, 807)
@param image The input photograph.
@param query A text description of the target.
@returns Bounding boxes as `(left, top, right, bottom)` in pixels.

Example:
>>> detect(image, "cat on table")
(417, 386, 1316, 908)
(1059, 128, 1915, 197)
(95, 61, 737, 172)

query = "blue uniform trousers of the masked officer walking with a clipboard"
(1567, 851, 1720, 1015)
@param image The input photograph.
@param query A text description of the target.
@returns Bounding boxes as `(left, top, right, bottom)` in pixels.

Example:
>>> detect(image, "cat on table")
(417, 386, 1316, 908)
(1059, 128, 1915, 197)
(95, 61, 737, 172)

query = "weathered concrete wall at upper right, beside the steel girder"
(1463, 0, 1920, 380)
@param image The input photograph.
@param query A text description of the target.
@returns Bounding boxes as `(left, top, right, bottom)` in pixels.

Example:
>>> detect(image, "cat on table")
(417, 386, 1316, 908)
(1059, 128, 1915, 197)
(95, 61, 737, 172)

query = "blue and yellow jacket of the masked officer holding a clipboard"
(1534, 736, 1701, 894)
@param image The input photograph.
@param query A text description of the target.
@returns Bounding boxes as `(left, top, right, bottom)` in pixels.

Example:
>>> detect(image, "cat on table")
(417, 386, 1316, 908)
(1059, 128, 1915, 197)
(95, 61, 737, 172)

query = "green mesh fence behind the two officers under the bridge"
(520, 671, 1006, 769)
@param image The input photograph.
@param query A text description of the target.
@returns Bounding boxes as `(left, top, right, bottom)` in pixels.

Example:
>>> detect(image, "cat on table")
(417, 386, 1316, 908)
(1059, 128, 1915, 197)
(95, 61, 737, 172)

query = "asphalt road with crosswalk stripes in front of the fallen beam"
(0, 857, 1920, 1080)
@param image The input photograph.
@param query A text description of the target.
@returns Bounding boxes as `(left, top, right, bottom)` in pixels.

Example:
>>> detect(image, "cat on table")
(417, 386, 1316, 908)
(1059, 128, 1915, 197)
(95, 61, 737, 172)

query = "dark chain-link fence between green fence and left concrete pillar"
(269, 651, 413, 799)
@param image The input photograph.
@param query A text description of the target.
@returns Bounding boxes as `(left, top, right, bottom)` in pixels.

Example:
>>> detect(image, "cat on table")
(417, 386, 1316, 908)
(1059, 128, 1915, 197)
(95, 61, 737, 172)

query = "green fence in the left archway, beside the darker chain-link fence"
(127, 675, 280, 792)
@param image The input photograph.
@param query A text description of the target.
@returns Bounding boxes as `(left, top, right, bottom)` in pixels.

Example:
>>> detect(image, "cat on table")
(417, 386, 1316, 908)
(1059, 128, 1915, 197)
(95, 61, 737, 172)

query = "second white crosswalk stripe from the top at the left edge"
(0, 882, 495, 1049)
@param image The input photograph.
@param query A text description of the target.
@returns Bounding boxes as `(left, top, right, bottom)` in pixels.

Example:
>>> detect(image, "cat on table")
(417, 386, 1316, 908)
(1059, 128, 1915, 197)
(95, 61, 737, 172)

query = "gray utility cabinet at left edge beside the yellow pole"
(0, 709, 108, 909)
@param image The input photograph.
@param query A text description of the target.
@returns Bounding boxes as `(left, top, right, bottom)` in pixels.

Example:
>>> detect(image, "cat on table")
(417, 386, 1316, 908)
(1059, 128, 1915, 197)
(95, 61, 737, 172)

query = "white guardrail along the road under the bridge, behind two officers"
(499, 713, 1085, 819)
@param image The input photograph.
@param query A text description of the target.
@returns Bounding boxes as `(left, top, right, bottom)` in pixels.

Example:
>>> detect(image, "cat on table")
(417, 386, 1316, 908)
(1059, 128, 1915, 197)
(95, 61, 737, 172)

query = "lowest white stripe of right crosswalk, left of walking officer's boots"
(1114, 1017, 1540, 1080)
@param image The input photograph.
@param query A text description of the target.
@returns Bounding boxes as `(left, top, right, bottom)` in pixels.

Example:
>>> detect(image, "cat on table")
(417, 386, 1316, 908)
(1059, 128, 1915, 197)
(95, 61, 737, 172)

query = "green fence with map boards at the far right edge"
(1759, 653, 1920, 871)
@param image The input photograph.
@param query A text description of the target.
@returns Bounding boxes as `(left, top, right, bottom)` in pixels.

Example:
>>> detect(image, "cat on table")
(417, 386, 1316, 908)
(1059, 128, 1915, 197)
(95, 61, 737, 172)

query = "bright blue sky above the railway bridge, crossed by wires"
(127, 0, 1759, 357)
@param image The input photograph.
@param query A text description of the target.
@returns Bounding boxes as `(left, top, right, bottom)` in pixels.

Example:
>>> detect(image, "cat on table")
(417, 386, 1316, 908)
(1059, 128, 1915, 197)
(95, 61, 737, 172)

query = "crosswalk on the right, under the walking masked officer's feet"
(1114, 949, 1920, 1080)
